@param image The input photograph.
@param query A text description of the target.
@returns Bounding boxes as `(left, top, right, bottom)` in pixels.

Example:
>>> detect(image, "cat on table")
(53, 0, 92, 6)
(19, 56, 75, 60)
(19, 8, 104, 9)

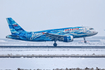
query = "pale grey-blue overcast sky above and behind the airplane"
(0, 0, 105, 38)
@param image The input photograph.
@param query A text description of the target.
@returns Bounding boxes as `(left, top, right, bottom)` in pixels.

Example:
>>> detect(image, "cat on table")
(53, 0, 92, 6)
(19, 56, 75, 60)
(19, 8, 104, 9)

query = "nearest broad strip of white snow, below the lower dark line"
(0, 58, 105, 70)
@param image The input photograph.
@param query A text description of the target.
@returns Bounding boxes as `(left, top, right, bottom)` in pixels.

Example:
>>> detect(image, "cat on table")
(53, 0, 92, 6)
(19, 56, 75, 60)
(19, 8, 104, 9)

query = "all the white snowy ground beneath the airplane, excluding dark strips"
(0, 38, 105, 70)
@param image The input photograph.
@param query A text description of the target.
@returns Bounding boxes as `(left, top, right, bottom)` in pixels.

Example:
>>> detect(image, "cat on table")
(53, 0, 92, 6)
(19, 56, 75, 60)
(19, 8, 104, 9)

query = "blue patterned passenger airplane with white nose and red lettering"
(6, 18, 98, 47)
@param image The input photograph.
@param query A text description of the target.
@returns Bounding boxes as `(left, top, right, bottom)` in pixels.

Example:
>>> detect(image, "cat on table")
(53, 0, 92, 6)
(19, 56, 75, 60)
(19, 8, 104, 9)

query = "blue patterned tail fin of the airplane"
(6, 18, 25, 35)
